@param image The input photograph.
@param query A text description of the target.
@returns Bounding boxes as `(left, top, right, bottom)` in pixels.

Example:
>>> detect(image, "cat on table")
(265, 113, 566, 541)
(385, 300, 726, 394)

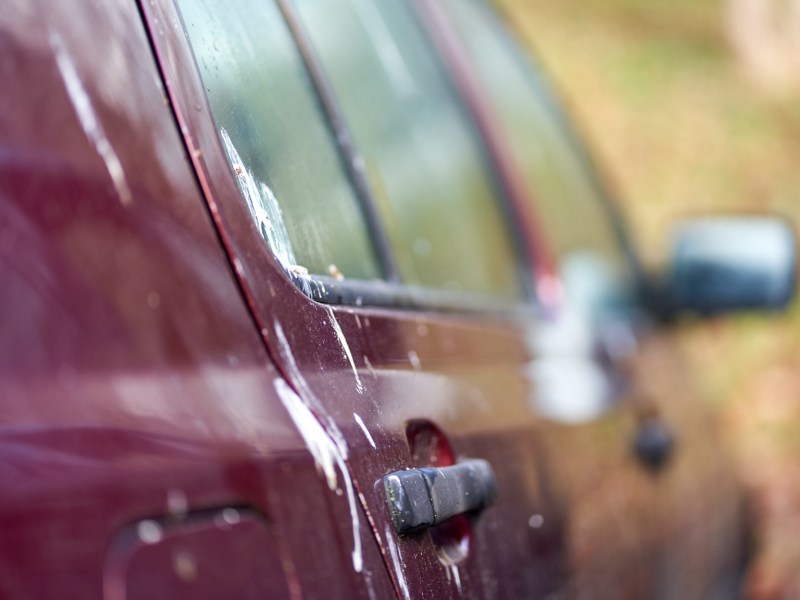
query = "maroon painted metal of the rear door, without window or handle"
(142, 2, 562, 597)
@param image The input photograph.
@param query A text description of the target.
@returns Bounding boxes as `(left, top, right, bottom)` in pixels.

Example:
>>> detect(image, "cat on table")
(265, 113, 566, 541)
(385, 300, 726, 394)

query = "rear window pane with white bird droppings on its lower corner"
(178, 0, 381, 279)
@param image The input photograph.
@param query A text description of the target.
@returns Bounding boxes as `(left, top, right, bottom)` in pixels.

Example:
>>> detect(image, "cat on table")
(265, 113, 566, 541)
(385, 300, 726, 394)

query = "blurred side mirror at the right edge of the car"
(658, 217, 797, 317)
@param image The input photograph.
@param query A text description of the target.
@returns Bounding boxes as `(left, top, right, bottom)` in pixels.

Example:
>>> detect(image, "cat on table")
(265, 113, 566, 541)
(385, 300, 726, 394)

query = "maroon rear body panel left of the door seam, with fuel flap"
(0, 2, 393, 598)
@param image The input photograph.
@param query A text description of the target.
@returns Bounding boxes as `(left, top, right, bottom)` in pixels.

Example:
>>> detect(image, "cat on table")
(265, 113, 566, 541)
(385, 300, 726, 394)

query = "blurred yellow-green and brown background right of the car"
(497, 0, 800, 599)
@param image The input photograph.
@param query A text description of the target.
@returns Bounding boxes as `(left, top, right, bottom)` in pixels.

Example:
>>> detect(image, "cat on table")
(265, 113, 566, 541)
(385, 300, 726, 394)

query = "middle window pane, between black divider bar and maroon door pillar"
(294, 0, 522, 297)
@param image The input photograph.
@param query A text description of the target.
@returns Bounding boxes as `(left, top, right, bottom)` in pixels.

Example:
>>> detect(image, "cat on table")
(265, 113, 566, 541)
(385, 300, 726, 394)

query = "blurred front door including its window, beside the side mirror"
(432, 0, 752, 598)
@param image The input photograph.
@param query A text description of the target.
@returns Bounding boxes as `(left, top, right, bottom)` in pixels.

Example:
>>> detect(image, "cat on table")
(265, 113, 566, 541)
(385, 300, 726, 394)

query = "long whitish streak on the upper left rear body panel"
(48, 32, 133, 204)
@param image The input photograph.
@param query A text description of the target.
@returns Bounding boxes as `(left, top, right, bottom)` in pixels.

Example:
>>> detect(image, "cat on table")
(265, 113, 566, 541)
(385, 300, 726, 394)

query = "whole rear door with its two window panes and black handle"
(144, 0, 564, 598)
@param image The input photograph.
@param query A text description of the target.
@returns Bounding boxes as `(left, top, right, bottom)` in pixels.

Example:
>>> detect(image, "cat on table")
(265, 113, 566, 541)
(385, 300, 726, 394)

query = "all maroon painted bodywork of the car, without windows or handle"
(0, 0, 752, 598)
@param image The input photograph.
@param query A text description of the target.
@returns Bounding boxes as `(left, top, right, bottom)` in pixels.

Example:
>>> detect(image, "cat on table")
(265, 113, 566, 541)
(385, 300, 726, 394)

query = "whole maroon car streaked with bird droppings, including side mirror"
(0, 0, 794, 600)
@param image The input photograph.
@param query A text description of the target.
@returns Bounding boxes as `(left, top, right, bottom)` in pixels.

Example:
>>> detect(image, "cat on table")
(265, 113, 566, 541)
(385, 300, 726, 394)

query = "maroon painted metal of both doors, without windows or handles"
(147, 0, 752, 598)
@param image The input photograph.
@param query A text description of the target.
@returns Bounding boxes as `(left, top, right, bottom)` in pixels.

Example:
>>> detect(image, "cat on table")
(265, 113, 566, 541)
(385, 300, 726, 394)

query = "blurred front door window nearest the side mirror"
(444, 0, 632, 316)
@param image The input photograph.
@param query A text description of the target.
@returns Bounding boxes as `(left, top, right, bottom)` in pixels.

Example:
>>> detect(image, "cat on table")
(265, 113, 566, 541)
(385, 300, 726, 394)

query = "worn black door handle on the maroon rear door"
(383, 459, 497, 535)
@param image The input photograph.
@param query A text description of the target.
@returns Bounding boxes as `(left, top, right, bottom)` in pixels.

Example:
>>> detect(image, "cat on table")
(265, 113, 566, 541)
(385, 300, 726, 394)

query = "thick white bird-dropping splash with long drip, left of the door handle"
(275, 379, 364, 573)
